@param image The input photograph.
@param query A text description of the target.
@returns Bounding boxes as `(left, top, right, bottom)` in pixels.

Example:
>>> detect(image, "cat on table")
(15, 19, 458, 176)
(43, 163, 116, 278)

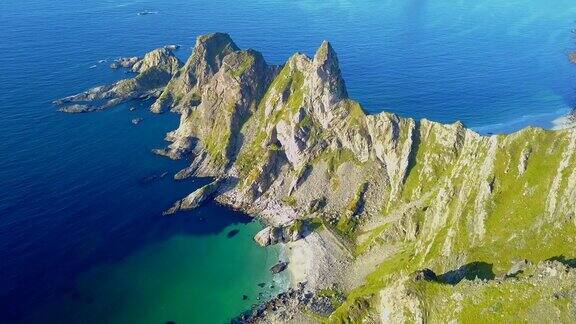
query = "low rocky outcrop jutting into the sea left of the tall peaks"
(54, 48, 181, 113)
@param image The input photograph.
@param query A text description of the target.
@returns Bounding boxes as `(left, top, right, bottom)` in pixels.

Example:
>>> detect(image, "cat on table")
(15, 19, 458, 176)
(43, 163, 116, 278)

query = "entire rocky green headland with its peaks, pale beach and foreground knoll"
(55, 33, 576, 323)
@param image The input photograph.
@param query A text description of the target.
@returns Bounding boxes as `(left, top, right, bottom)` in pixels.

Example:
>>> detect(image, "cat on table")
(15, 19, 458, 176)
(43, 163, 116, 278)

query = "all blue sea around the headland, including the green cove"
(0, 0, 576, 323)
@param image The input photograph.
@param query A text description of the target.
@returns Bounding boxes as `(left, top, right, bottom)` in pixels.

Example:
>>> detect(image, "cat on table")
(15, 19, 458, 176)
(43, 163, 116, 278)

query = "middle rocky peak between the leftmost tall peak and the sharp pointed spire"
(158, 50, 277, 175)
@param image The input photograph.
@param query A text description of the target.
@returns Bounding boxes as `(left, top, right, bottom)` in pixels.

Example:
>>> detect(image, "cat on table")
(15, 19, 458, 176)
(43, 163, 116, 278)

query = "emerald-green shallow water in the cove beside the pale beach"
(24, 218, 286, 323)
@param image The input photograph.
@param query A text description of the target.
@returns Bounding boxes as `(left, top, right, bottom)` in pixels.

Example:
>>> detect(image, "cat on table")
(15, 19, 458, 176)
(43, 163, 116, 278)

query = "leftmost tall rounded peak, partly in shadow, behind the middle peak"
(151, 33, 240, 113)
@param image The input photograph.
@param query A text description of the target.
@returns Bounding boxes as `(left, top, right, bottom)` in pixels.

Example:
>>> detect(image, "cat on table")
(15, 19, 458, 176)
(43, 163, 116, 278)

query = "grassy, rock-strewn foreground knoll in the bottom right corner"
(406, 262, 576, 323)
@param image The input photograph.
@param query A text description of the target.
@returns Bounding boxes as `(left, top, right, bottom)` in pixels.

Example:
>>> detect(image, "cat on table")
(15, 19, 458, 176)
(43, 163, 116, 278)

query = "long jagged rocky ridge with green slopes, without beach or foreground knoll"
(57, 33, 576, 322)
